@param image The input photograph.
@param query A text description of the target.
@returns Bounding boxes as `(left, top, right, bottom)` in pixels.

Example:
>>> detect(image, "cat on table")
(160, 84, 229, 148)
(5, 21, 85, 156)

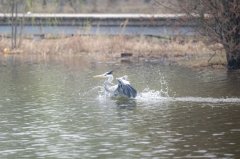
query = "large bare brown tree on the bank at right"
(178, 0, 240, 69)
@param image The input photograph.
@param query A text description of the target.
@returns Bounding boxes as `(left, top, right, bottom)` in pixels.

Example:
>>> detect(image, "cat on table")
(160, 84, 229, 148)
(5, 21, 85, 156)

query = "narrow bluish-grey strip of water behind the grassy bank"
(0, 26, 196, 36)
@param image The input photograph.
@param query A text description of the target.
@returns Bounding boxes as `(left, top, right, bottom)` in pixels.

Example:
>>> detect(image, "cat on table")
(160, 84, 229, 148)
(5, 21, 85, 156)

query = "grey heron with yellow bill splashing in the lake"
(94, 71, 137, 98)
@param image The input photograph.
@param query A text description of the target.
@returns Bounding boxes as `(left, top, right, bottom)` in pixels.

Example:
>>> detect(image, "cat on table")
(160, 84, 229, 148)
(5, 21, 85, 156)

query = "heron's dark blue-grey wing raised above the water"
(114, 78, 137, 98)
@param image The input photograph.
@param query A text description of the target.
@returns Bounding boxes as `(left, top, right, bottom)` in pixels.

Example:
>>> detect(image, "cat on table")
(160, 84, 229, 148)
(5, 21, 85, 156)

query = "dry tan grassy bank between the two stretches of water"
(0, 35, 226, 68)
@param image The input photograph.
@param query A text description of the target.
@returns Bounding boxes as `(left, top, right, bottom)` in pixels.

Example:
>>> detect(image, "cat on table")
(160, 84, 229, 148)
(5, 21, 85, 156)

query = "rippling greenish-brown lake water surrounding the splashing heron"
(0, 56, 240, 159)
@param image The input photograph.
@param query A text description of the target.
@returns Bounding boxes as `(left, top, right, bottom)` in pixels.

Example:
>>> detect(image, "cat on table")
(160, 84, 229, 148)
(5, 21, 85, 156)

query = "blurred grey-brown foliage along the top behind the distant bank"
(0, 0, 180, 14)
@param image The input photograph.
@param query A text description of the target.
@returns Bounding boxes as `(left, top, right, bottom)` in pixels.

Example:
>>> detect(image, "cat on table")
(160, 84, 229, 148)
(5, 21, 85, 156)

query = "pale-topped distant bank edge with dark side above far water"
(0, 13, 198, 27)
